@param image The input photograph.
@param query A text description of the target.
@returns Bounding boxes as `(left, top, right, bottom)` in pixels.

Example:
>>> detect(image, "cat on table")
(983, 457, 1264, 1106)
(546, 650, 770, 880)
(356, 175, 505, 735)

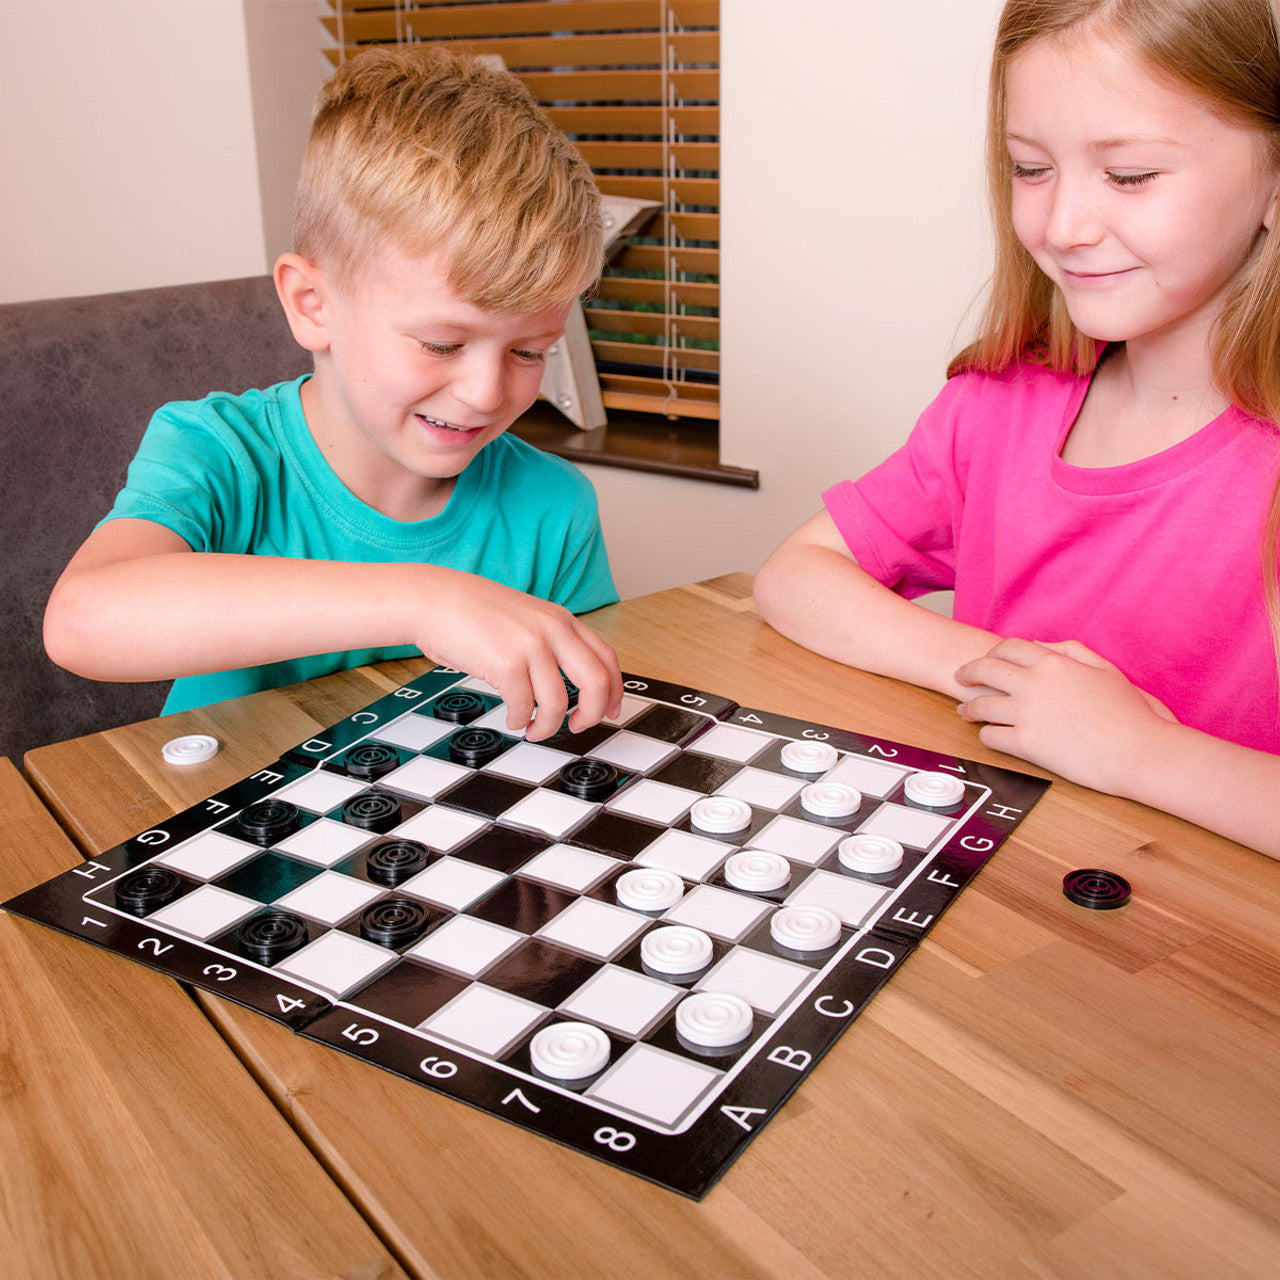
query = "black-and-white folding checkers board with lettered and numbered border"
(5, 668, 1047, 1197)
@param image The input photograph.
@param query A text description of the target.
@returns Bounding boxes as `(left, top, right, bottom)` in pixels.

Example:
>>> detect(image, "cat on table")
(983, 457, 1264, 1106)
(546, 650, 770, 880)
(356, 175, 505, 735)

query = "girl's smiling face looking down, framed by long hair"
(1007, 37, 1277, 355)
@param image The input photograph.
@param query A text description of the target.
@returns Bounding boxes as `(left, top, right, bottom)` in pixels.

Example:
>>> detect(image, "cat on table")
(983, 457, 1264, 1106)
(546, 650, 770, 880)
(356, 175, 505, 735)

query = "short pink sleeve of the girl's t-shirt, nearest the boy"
(822, 375, 965, 599)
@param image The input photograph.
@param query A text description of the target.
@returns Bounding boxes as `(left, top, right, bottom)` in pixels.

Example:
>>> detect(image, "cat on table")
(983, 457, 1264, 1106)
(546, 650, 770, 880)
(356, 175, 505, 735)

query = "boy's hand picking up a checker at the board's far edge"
(413, 570, 622, 742)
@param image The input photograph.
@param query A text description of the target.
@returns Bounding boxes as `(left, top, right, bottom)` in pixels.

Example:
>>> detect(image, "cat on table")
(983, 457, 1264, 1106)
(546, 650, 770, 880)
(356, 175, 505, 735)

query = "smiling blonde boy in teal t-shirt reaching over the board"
(45, 47, 622, 739)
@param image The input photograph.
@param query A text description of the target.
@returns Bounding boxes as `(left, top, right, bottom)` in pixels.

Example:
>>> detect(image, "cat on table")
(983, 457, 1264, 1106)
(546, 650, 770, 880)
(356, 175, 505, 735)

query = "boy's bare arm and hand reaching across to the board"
(45, 520, 622, 741)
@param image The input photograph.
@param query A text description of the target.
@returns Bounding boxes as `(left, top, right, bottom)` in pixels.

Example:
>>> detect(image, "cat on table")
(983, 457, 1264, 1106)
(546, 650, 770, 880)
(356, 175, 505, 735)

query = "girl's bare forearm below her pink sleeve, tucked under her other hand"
(755, 511, 1000, 699)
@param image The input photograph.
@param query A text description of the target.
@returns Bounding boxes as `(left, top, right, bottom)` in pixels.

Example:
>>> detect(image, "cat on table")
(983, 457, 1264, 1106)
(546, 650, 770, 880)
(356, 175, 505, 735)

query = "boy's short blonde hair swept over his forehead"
(293, 45, 604, 312)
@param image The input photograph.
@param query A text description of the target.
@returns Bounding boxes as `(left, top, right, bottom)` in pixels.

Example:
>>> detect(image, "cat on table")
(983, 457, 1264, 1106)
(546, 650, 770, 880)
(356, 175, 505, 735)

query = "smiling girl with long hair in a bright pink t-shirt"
(756, 0, 1280, 856)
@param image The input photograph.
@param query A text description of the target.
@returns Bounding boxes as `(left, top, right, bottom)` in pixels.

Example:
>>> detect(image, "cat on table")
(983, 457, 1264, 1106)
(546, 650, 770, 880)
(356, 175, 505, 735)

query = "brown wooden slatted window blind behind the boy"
(321, 0, 719, 421)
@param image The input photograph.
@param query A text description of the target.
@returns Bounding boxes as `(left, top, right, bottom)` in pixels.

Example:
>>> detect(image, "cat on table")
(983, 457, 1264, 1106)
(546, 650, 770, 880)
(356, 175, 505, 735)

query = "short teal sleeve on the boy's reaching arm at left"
(102, 391, 260, 552)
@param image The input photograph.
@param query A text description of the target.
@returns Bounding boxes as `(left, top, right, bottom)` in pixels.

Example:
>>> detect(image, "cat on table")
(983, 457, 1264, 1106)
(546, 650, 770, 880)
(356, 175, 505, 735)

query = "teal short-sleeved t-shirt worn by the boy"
(106, 378, 618, 713)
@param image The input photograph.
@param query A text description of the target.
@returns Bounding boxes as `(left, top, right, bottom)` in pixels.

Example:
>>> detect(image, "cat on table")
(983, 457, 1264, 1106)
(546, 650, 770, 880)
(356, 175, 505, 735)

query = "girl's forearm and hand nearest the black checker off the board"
(956, 640, 1280, 858)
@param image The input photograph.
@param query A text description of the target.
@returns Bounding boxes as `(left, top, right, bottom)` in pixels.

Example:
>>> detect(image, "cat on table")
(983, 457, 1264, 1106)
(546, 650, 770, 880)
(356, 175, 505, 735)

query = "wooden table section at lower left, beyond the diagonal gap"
(0, 760, 401, 1280)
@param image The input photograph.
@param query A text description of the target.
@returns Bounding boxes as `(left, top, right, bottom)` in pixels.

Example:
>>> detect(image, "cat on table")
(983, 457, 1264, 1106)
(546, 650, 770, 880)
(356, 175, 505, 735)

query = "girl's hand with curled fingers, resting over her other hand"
(956, 639, 1176, 792)
